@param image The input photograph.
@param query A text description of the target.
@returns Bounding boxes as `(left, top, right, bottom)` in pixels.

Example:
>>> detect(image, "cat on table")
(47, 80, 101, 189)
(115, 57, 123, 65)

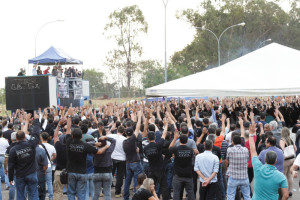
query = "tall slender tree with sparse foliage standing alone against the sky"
(105, 5, 148, 90)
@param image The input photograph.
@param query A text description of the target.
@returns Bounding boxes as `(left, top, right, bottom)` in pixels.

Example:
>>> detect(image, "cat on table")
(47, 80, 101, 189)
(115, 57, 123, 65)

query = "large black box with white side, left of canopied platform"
(5, 76, 57, 110)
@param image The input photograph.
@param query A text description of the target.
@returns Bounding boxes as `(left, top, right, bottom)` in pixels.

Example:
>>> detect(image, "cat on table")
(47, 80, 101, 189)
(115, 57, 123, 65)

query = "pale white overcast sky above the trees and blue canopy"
(0, 0, 290, 88)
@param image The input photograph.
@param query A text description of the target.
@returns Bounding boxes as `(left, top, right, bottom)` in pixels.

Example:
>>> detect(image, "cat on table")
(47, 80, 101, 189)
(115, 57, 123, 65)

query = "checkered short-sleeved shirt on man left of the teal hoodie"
(226, 144, 249, 179)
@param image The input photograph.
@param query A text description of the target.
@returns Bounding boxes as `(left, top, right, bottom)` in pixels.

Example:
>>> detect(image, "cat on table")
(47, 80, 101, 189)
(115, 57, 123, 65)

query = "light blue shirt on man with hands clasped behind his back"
(194, 151, 219, 183)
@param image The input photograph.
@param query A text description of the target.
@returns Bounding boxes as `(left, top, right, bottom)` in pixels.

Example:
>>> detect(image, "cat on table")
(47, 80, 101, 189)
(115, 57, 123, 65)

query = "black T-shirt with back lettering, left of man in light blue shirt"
(170, 145, 194, 178)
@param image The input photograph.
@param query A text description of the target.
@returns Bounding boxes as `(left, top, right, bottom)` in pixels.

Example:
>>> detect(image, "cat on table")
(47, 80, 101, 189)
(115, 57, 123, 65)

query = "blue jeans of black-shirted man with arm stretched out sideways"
(68, 173, 87, 200)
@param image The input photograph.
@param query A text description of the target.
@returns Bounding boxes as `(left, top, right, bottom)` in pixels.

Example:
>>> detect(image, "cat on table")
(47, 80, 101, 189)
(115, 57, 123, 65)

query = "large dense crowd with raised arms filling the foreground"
(0, 96, 300, 200)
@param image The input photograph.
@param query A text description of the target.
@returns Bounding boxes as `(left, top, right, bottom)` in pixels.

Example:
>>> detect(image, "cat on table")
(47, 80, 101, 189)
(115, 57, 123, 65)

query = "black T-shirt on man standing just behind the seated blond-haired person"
(144, 138, 165, 172)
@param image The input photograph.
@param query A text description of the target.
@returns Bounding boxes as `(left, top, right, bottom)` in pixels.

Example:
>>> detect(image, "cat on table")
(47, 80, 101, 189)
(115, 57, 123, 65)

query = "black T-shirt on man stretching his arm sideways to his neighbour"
(64, 134, 98, 174)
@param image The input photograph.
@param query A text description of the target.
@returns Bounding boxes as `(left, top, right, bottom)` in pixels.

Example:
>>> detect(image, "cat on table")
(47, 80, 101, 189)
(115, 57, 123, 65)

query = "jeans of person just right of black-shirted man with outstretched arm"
(93, 173, 112, 200)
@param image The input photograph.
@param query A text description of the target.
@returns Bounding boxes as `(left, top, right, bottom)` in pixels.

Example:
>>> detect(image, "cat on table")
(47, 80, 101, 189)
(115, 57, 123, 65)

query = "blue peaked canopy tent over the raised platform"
(28, 46, 83, 65)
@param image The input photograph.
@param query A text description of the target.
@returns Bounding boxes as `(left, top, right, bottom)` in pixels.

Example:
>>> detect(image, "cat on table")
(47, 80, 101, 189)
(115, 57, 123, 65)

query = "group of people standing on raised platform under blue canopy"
(18, 62, 82, 78)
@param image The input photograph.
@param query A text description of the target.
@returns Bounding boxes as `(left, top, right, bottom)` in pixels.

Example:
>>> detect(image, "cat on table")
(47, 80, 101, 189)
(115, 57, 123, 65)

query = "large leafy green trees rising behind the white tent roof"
(171, 0, 300, 73)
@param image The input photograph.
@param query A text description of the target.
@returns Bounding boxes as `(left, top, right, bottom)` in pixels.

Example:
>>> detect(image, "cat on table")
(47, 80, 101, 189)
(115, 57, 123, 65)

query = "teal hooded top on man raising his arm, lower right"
(252, 156, 288, 200)
